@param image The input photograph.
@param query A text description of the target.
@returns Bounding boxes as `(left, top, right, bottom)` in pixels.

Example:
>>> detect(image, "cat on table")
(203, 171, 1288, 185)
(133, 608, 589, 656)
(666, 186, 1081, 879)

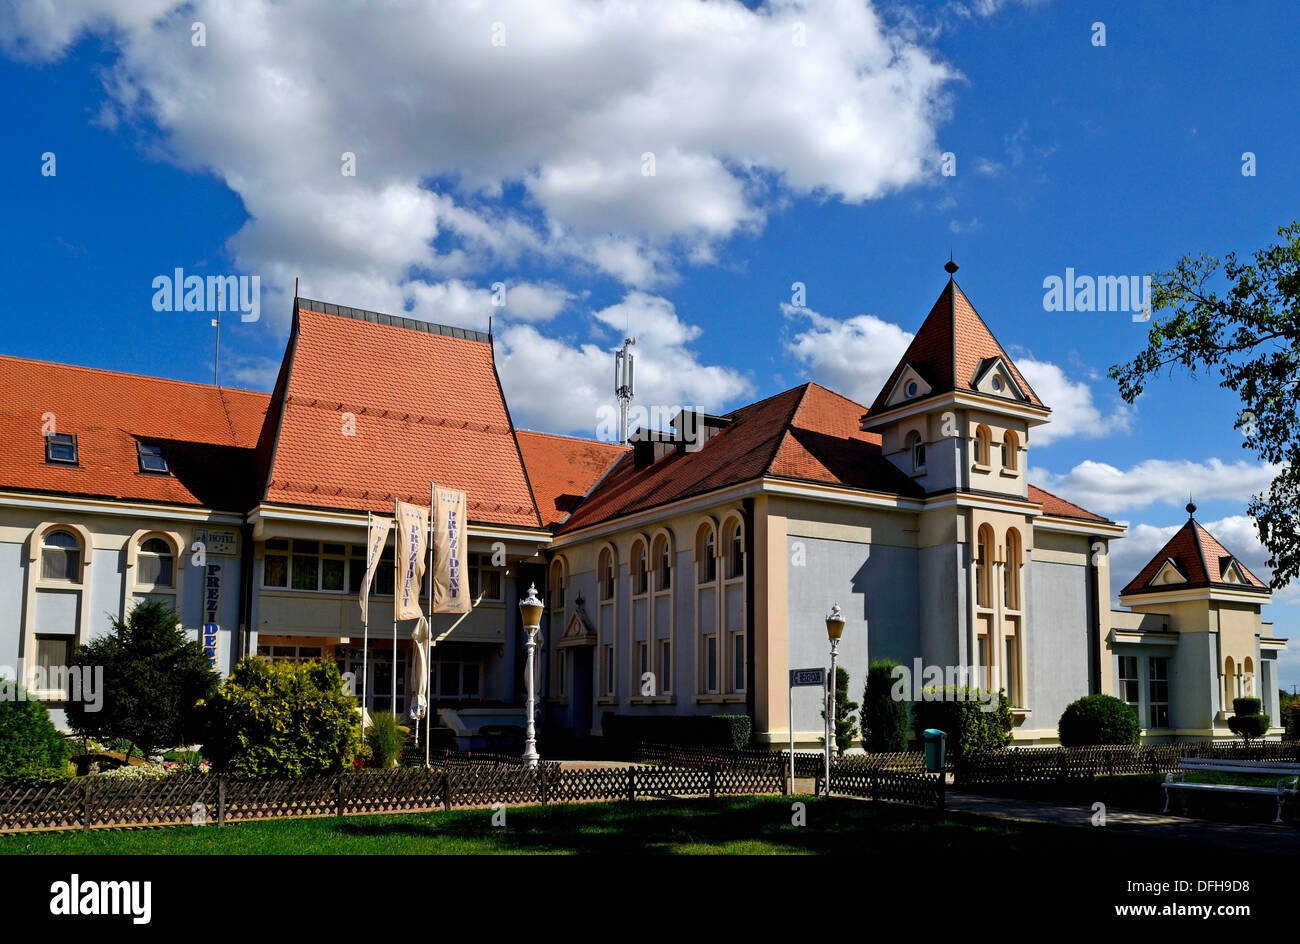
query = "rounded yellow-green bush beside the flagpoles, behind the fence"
(203, 655, 361, 778)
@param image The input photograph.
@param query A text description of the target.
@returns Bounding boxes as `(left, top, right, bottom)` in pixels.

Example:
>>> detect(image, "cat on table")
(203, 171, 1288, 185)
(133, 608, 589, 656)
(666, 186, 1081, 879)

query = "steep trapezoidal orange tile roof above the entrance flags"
(259, 299, 541, 528)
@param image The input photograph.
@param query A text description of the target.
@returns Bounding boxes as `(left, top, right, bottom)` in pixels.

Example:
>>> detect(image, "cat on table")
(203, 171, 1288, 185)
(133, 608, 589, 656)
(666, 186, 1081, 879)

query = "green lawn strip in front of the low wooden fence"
(0, 797, 1279, 861)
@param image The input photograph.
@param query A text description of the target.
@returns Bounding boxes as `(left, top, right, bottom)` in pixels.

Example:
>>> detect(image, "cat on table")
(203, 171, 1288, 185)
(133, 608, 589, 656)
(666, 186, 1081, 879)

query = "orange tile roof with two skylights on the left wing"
(0, 355, 269, 511)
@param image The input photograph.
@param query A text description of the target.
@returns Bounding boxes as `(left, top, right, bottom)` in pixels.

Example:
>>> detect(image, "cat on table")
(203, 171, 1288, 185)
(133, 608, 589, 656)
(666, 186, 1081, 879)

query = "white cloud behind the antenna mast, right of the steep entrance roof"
(495, 291, 754, 437)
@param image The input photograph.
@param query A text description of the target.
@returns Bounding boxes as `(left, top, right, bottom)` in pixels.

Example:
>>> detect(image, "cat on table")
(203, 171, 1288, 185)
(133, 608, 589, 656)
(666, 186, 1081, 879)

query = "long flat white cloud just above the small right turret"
(1030, 459, 1277, 515)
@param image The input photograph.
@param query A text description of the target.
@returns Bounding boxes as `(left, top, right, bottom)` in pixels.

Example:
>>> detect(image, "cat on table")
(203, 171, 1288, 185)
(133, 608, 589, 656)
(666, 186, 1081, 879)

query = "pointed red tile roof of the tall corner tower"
(867, 278, 1043, 413)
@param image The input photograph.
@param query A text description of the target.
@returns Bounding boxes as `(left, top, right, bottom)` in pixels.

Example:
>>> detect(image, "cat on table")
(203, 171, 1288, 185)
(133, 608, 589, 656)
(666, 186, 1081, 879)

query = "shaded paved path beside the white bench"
(945, 791, 1300, 856)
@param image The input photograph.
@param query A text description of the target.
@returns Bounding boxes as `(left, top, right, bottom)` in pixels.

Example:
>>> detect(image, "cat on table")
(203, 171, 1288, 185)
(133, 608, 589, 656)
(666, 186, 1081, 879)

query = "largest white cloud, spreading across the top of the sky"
(0, 0, 956, 299)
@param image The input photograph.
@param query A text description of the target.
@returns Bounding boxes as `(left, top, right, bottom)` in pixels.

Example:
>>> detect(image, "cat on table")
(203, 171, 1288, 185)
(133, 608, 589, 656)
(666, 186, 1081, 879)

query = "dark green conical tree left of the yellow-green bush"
(68, 599, 218, 757)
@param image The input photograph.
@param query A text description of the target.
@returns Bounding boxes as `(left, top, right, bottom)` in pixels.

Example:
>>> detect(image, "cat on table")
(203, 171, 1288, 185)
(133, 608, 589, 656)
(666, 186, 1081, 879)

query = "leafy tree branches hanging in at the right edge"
(1110, 221, 1300, 588)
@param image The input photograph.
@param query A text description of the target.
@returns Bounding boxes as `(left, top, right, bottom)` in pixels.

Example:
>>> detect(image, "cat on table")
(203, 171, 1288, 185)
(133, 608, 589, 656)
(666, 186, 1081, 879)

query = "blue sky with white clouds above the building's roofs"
(0, 0, 1300, 687)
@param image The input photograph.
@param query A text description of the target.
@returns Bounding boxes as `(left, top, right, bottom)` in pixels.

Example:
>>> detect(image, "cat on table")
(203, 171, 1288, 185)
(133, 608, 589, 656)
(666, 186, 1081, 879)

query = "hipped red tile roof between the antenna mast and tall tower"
(559, 384, 924, 533)
